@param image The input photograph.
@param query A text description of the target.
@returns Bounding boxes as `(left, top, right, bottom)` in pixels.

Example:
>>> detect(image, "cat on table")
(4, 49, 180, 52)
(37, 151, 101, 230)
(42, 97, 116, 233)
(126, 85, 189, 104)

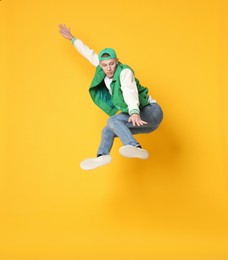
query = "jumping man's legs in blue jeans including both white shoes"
(80, 104, 163, 170)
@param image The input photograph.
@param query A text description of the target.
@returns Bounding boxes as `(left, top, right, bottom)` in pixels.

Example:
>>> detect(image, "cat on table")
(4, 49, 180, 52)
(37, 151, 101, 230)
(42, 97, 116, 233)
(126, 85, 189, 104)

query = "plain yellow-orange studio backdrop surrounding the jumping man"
(0, 0, 228, 260)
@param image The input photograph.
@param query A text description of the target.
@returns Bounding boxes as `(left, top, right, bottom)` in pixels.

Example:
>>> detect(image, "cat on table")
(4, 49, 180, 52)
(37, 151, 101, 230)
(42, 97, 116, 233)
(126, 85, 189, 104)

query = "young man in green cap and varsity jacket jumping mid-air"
(59, 24, 163, 170)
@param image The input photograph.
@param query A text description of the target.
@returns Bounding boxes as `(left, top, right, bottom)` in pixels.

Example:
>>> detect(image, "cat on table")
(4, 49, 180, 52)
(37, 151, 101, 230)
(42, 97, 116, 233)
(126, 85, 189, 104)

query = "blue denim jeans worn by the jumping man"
(97, 103, 163, 155)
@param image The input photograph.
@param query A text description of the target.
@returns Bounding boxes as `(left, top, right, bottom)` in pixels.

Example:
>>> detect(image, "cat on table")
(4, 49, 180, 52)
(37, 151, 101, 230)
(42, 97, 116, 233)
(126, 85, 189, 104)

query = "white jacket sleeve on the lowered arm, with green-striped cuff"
(120, 68, 140, 115)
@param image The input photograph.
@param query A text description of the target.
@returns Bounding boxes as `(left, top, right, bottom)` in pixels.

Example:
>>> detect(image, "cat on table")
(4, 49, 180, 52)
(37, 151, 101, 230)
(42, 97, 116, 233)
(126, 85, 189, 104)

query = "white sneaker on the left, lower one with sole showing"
(80, 155, 112, 170)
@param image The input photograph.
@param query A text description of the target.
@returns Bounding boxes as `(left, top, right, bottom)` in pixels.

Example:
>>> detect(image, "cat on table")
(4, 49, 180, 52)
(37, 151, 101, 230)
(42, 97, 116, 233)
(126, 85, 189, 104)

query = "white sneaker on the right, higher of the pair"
(119, 145, 149, 160)
